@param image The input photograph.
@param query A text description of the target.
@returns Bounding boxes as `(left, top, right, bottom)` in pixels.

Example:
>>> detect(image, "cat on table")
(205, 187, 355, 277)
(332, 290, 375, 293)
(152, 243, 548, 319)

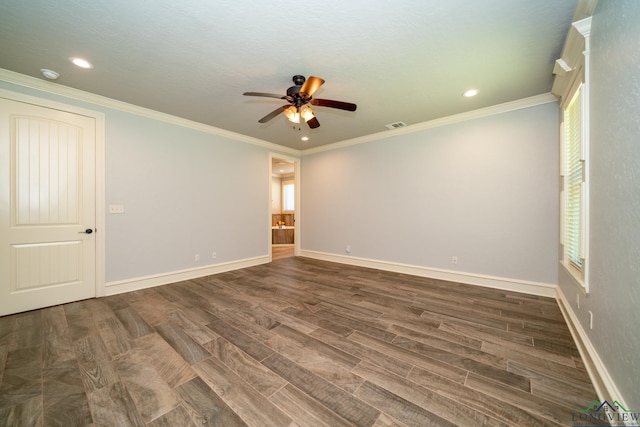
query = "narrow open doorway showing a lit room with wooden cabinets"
(269, 154, 300, 261)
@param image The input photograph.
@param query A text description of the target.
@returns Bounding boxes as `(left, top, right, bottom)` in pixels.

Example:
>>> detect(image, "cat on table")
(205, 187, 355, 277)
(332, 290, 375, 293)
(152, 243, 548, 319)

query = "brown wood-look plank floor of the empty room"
(0, 257, 596, 427)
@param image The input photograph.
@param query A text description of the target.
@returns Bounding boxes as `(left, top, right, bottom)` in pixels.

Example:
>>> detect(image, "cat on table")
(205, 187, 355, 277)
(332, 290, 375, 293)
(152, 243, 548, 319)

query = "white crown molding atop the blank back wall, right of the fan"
(302, 93, 558, 156)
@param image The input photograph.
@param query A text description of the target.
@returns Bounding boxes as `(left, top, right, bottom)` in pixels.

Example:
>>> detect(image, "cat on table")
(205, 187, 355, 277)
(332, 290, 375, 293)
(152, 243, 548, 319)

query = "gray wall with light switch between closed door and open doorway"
(0, 81, 288, 283)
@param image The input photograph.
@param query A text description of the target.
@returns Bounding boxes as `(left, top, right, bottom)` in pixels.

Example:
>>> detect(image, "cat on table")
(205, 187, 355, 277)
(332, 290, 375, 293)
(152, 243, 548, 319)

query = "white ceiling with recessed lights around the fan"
(0, 0, 576, 149)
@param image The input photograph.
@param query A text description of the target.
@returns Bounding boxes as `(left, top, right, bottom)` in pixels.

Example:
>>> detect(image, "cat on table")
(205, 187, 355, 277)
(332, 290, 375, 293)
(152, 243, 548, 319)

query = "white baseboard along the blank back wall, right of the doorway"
(300, 250, 557, 298)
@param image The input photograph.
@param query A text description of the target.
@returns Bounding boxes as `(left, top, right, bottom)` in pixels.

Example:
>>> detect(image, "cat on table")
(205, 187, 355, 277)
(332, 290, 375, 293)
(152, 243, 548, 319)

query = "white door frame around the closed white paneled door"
(0, 88, 106, 297)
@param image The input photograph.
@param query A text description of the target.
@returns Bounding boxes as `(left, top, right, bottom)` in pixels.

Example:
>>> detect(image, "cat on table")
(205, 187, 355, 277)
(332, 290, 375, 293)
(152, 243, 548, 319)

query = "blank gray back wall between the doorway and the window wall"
(301, 102, 559, 284)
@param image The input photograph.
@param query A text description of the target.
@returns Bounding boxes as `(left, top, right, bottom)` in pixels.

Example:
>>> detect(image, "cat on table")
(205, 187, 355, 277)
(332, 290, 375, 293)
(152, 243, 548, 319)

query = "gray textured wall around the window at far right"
(560, 0, 640, 410)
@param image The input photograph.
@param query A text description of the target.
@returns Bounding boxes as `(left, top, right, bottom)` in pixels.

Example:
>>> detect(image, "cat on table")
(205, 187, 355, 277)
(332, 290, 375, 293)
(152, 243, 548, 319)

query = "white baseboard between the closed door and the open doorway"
(103, 255, 271, 296)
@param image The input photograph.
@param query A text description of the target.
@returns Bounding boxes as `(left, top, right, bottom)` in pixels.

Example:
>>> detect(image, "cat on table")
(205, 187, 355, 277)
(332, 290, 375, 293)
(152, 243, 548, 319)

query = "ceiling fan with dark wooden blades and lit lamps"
(243, 75, 357, 129)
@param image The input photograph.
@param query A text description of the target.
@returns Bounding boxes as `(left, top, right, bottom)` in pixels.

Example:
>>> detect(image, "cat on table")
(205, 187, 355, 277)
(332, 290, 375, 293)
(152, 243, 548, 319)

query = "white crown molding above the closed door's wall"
(0, 68, 300, 157)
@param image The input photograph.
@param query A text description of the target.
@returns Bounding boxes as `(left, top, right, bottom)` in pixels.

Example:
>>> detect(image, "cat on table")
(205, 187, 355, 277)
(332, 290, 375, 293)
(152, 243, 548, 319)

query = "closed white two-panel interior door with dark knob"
(0, 98, 96, 315)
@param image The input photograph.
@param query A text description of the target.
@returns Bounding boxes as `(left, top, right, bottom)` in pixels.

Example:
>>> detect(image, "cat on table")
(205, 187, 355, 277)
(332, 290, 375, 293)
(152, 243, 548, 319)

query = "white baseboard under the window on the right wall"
(556, 286, 625, 412)
